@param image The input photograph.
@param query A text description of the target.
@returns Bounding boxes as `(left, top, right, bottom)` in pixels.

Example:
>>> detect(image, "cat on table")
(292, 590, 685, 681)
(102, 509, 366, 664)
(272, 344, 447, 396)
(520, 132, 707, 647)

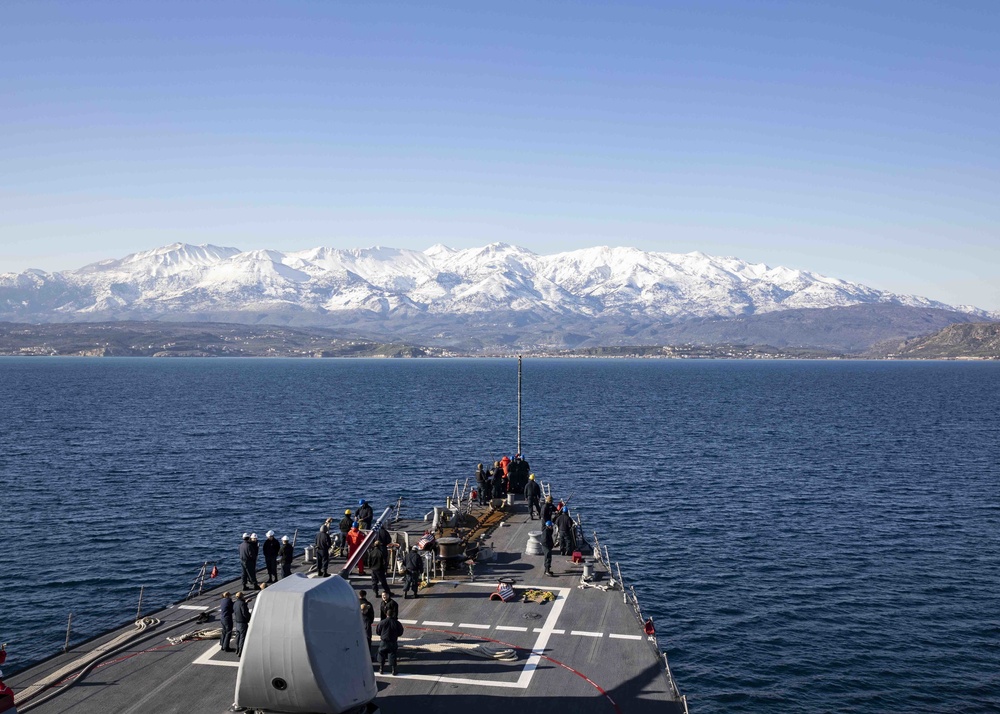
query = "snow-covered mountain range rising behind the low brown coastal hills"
(0, 243, 986, 348)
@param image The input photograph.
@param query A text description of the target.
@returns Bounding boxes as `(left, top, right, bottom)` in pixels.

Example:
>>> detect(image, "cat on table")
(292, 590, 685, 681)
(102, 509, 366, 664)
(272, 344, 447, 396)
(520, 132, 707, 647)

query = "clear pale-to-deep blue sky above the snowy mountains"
(0, 0, 1000, 310)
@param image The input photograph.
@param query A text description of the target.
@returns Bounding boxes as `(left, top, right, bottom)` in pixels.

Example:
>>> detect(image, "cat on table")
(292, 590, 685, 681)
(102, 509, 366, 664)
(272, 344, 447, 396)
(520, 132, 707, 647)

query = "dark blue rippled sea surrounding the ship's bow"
(0, 358, 1000, 714)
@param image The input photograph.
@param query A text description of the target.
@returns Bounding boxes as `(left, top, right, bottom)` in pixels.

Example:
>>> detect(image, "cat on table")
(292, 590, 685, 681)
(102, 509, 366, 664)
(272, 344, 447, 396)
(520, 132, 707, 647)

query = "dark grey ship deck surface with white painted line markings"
(7, 492, 687, 714)
